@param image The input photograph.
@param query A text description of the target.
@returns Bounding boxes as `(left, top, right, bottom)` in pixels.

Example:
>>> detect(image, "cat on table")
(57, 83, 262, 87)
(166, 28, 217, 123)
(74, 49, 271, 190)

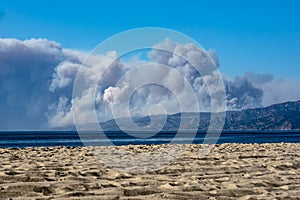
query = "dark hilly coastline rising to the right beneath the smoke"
(55, 101, 300, 131)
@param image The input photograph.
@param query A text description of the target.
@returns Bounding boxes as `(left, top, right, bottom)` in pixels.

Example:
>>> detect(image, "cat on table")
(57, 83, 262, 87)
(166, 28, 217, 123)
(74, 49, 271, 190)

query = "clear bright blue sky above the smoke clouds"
(0, 0, 300, 79)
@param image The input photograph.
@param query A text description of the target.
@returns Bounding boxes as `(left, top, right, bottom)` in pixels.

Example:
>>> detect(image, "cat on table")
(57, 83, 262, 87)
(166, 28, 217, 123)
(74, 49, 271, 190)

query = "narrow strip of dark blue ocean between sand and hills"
(0, 131, 300, 147)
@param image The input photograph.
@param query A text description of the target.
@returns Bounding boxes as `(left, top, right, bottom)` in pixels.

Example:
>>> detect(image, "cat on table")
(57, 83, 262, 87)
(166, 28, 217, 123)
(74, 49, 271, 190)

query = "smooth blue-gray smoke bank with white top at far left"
(0, 39, 80, 129)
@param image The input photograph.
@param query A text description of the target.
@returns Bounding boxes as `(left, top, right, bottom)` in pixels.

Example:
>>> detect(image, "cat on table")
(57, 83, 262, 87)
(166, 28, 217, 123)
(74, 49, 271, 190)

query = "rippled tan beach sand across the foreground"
(0, 143, 300, 200)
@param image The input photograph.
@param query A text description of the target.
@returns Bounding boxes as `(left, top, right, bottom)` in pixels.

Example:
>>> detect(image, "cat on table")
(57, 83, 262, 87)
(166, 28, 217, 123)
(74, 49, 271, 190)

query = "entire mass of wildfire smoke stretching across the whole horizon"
(0, 39, 300, 129)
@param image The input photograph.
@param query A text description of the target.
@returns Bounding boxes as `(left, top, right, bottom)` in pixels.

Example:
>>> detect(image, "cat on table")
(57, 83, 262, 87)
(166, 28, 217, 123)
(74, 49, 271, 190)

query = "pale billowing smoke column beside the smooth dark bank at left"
(48, 52, 123, 127)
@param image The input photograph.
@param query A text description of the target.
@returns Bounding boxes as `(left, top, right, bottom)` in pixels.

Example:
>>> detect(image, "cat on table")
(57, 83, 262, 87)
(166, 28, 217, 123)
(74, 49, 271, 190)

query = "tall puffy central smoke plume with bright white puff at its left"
(99, 40, 218, 117)
